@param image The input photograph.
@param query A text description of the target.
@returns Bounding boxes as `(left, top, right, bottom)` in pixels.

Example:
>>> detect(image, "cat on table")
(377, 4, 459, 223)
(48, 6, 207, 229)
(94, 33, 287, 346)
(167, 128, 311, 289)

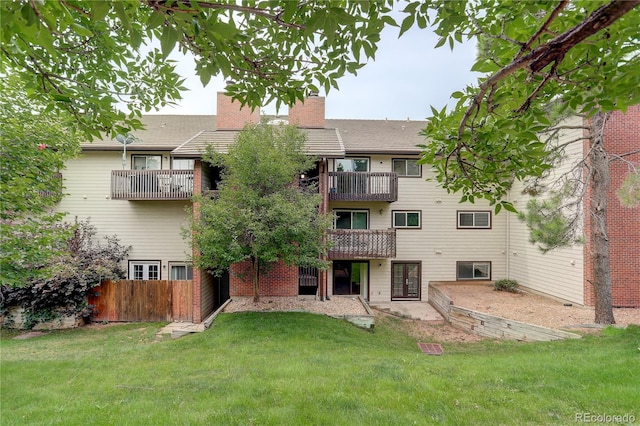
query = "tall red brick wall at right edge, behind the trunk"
(584, 105, 640, 307)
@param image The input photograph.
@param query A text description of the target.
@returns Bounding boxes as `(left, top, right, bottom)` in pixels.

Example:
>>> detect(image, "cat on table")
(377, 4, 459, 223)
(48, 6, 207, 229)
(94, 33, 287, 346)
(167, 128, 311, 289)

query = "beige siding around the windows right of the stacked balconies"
(329, 155, 507, 302)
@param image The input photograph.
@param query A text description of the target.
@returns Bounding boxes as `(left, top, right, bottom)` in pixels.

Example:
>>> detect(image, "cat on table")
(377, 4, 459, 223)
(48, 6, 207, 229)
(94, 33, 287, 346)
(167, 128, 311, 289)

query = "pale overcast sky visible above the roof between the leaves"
(156, 23, 476, 120)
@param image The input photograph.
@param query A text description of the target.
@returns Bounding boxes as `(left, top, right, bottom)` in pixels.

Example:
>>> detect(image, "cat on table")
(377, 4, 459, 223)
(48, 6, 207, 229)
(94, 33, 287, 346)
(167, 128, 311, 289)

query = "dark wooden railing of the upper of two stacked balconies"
(329, 172, 398, 202)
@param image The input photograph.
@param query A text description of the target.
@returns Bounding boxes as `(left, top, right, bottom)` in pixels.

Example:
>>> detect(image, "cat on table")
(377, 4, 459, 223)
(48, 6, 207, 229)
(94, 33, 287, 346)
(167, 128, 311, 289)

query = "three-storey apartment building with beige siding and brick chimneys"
(59, 93, 640, 322)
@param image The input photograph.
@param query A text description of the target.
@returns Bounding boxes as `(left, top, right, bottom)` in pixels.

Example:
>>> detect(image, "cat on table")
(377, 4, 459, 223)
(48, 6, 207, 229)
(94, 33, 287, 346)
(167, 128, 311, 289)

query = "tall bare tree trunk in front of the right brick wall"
(588, 113, 615, 324)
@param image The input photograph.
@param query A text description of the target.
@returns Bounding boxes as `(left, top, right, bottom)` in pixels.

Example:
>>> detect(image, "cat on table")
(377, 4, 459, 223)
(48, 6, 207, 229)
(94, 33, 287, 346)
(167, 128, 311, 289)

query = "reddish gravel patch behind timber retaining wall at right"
(437, 284, 640, 331)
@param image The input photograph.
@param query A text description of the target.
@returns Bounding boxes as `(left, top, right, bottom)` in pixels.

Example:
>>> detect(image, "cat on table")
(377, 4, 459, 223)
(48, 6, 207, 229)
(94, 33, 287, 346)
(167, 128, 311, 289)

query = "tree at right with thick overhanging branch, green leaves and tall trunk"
(410, 0, 640, 324)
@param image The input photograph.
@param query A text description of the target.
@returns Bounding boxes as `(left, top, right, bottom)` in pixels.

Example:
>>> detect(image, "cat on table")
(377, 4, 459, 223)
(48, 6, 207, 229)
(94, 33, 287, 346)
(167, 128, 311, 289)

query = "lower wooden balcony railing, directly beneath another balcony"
(328, 229, 396, 259)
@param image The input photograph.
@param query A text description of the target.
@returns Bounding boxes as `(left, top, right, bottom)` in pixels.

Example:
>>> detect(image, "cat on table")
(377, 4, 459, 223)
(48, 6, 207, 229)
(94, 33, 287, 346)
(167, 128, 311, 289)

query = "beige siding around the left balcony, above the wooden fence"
(58, 152, 191, 279)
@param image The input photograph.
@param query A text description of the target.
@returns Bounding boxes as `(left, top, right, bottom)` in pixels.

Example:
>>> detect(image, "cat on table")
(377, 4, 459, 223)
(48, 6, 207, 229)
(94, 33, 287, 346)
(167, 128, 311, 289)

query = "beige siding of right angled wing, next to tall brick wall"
(509, 119, 584, 304)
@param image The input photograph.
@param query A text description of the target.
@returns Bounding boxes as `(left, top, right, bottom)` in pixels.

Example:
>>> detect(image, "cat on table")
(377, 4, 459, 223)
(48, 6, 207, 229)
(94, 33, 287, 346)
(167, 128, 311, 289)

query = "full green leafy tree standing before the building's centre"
(191, 122, 331, 301)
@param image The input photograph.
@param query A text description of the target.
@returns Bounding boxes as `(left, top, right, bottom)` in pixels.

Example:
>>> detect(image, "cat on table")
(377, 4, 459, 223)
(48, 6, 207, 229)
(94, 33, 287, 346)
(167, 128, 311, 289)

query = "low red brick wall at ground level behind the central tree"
(229, 261, 298, 298)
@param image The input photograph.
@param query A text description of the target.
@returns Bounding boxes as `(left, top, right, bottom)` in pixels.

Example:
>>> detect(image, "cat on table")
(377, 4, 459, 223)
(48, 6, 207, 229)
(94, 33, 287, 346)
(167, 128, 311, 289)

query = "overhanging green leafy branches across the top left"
(0, 0, 394, 137)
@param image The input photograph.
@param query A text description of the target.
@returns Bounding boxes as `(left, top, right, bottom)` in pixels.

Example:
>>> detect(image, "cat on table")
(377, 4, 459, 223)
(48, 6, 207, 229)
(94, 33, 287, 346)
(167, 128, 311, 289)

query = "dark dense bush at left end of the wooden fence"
(0, 221, 129, 328)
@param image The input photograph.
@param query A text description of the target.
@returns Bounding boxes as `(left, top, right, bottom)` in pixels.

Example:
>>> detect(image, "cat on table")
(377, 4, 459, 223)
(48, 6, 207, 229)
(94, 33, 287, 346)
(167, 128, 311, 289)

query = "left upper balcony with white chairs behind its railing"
(111, 170, 193, 200)
